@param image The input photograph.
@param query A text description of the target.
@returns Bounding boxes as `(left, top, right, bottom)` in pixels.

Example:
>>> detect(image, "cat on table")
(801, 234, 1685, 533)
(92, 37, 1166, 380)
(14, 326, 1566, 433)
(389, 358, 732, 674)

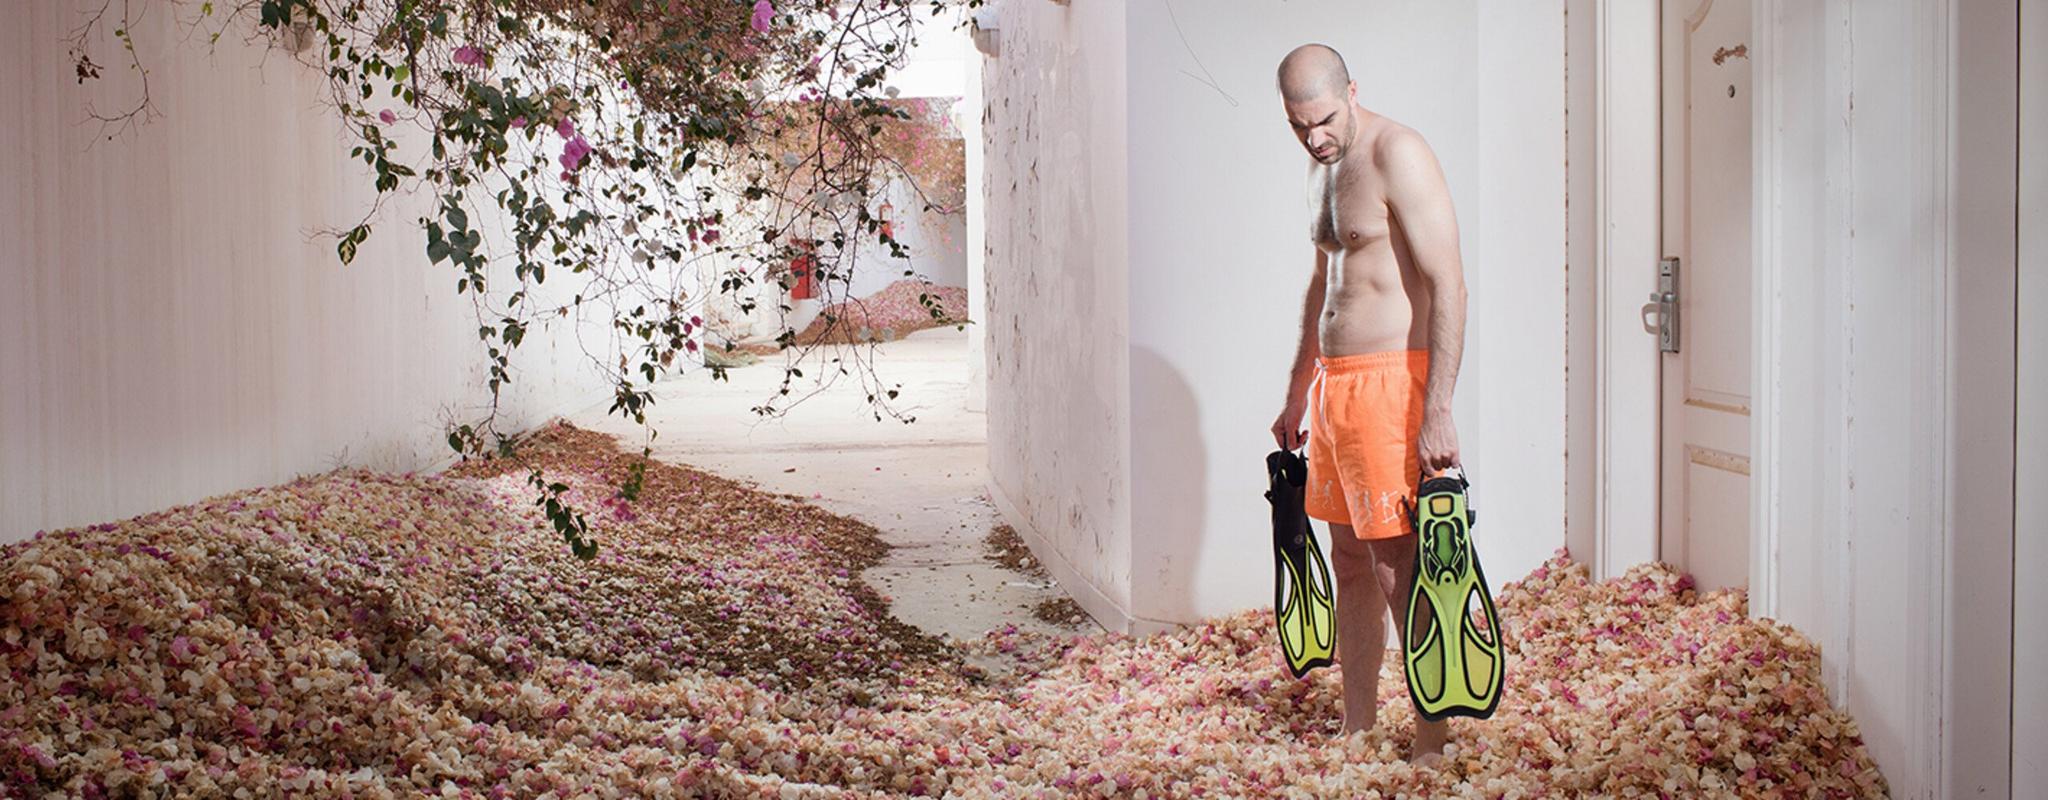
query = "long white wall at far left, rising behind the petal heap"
(0, 0, 608, 540)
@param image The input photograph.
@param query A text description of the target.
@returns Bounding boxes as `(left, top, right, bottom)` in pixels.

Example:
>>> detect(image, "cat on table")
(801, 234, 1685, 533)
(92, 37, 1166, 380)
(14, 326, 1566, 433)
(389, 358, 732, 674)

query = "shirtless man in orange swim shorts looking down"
(1272, 45, 1464, 761)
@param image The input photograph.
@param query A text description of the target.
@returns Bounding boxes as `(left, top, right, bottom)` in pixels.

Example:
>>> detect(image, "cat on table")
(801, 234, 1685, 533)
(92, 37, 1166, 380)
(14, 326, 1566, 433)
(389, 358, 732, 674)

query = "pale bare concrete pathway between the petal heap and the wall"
(552, 327, 1100, 669)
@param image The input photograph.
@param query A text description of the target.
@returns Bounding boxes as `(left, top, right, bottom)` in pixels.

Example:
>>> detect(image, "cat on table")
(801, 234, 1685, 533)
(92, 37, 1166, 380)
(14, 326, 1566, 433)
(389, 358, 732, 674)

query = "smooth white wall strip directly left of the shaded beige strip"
(1845, 2, 1950, 798)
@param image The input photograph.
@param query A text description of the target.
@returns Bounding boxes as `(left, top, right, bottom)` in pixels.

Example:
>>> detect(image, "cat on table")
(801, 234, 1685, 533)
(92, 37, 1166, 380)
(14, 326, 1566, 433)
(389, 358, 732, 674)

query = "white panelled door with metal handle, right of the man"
(1642, 0, 1751, 589)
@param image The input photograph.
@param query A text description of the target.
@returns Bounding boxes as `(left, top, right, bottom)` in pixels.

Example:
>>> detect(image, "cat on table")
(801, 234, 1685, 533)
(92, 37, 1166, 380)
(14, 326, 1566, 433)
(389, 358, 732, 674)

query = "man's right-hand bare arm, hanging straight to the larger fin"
(1384, 131, 1464, 469)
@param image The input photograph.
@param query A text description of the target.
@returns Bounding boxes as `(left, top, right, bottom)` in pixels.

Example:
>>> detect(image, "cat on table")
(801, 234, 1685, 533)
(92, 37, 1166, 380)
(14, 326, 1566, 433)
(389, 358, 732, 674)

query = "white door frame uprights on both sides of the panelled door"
(1591, 0, 1777, 593)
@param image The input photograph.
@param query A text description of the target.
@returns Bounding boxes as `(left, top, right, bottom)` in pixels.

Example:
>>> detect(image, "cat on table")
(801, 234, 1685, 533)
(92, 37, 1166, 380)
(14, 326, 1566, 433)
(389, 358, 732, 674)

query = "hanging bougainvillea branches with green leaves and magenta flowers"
(72, 0, 981, 557)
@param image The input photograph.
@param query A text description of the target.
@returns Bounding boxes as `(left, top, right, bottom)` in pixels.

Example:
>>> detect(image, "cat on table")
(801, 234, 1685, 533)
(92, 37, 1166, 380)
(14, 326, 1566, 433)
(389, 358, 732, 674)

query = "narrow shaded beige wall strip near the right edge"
(1935, 0, 2040, 798)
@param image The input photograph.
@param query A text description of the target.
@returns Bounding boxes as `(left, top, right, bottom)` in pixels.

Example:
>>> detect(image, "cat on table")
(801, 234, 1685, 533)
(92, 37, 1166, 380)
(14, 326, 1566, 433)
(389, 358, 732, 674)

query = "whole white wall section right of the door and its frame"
(1759, 2, 2023, 798)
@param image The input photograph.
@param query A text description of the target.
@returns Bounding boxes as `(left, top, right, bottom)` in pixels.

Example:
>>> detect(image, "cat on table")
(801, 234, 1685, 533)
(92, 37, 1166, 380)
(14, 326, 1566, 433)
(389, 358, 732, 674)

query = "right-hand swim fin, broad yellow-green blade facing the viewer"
(1401, 471, 1505, 720)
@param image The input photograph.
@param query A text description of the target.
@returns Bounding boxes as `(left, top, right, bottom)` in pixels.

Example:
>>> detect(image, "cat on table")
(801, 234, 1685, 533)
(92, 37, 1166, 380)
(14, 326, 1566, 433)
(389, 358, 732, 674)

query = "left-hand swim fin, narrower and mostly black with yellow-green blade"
(1266, 450, 1337, 677)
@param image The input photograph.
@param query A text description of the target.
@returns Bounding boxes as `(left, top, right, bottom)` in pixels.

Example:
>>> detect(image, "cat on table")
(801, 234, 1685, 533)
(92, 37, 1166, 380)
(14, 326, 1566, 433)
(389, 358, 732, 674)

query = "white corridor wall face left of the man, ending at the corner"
(983, 0, 1143, 628)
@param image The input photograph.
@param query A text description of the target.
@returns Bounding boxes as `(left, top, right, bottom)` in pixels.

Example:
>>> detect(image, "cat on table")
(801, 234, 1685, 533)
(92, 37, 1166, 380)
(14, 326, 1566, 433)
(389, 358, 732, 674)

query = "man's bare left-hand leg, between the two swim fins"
(1329, 524, 1386, 735)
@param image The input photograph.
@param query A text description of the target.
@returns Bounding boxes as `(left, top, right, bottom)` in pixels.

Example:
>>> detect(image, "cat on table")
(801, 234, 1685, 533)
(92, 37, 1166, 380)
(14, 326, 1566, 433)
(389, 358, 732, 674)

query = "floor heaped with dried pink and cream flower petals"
(0, 426, 1884, 798)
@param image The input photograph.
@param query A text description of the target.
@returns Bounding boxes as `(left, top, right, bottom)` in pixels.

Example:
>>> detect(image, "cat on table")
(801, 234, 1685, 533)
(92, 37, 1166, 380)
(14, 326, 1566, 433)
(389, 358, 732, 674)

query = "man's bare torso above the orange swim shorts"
(1309, 115, 1430, 356)
